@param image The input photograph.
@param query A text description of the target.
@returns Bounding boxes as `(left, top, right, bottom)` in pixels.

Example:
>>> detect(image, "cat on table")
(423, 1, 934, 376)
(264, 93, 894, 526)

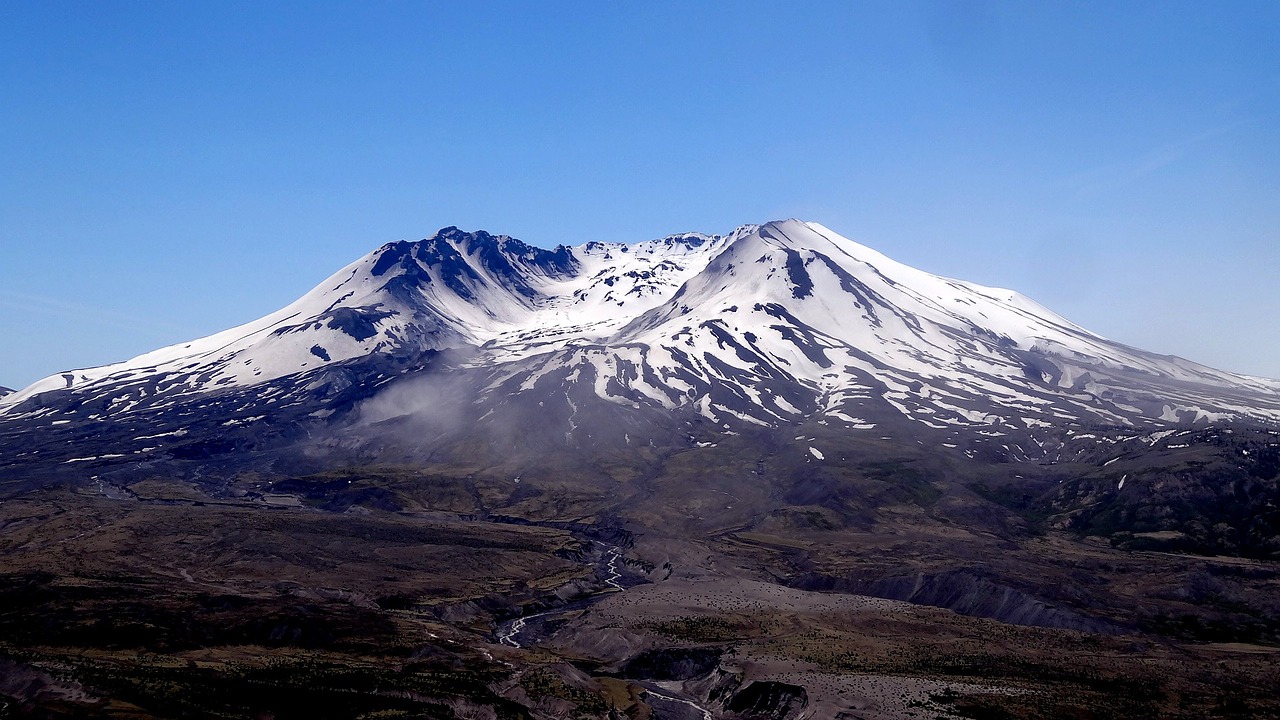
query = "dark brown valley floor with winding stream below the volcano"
(0, 479, 1280, 720)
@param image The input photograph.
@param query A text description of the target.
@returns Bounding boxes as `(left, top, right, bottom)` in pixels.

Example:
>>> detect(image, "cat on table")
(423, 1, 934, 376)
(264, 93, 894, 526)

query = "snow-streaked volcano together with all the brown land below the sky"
(0, 220, 1280, 720)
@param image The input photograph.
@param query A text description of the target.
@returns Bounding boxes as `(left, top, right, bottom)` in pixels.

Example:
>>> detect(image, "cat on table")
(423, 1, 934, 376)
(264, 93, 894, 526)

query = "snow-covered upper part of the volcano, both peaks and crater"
(0, 220, 1280, 453)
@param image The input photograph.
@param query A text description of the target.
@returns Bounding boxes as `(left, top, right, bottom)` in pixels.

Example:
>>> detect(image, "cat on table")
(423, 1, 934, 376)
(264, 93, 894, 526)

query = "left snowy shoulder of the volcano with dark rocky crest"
(4, 228, 572, 411)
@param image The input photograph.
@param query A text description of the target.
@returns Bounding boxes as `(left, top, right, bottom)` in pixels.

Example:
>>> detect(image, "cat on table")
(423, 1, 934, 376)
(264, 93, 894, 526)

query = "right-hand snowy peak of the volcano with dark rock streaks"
(524, 220, 1280, 429)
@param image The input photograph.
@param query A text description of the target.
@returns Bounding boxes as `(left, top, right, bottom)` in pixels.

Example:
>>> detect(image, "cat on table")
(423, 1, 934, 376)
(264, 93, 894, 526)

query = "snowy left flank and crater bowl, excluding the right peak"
(0, 222, 714, 416)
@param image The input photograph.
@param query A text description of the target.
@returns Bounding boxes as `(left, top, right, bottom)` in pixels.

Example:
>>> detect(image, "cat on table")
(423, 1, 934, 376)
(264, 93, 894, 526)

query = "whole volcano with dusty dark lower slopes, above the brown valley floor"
(0, 220, 1280, 479)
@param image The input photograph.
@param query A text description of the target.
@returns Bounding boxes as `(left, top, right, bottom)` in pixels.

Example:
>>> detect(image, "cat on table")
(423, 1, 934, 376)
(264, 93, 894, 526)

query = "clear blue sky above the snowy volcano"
(0, 0, 1280, 387)
